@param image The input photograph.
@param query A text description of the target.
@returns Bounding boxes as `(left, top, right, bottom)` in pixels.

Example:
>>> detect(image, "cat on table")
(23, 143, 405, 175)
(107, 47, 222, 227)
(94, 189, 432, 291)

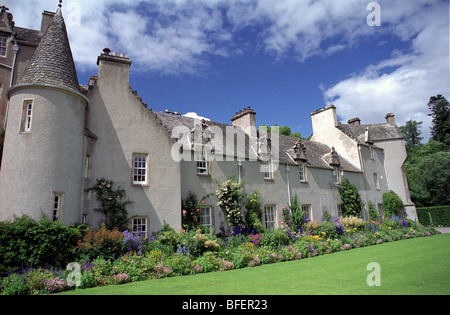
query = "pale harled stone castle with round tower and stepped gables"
(0, 3, 417, 232)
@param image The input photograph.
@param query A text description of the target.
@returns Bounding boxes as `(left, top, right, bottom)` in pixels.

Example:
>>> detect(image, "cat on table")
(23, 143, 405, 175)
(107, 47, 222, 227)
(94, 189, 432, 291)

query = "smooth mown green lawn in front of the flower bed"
(63, 234, 450, 295)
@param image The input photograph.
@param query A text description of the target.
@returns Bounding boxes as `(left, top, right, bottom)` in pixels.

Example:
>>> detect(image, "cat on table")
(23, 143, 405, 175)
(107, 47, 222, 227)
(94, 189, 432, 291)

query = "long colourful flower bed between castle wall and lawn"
(0, 217, 438, 294)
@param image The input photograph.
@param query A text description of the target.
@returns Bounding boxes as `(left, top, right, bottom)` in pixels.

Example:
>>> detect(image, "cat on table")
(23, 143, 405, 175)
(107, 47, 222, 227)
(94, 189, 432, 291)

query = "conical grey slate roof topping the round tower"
(19, 8, 80, 92)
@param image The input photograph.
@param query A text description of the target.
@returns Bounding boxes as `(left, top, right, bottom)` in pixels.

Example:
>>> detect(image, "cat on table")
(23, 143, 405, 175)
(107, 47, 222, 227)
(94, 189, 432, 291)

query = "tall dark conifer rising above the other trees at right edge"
(428, 94, 450, 145)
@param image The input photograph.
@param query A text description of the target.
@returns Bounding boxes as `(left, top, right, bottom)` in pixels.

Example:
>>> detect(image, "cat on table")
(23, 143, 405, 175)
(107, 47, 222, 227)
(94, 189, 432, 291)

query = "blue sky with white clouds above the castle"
(4, 0, 450, 141)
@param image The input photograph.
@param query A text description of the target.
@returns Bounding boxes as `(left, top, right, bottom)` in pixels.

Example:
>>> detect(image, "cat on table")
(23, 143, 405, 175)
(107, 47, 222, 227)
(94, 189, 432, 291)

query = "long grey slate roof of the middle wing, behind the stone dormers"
(152, 111, 360, 172)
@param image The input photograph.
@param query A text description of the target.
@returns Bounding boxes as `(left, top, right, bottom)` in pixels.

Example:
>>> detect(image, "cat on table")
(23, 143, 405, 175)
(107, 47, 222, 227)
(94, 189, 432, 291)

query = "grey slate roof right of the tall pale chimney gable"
(336, 123, 403, 144)
